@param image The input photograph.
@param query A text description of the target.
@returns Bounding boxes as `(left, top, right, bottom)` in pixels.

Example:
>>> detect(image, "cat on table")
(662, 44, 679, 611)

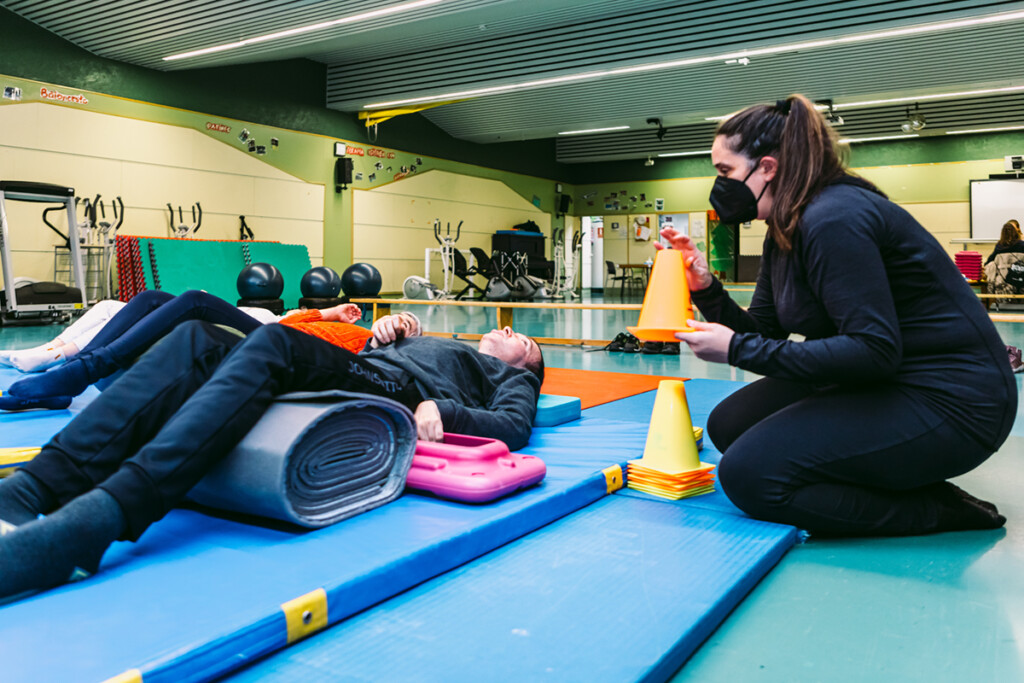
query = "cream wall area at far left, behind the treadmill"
(0, 103, 324, 280)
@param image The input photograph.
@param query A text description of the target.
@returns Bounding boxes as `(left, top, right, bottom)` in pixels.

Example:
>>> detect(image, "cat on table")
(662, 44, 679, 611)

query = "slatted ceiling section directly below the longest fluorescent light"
(417, 22, 1024, 141)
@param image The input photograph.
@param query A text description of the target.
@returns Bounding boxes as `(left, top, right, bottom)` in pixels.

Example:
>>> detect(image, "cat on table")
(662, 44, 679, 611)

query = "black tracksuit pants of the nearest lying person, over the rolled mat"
(25, 322, 422, 541)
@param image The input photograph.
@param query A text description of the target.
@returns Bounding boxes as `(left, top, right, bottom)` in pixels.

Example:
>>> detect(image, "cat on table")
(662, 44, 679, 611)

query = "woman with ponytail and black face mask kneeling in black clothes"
(662, 95, 1017, 536)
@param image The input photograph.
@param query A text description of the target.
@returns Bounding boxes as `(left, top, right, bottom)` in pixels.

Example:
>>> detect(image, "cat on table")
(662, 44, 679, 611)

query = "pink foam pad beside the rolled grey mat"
(406, 432, 548, 503)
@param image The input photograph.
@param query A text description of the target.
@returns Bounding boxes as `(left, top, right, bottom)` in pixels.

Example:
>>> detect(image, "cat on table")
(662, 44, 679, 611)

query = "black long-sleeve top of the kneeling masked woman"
(692, 177, 1017, 446)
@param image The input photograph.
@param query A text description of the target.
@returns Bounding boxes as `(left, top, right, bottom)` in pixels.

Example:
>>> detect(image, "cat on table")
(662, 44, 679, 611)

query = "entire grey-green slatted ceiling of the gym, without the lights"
(0, 0, 1024, 162)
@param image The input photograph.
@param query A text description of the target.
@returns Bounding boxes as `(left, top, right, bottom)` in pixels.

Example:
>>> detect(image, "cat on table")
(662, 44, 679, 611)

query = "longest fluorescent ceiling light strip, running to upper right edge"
(362, 11, 1024, 110)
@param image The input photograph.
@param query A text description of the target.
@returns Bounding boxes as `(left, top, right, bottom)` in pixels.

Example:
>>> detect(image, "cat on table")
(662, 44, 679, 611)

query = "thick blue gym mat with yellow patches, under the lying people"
(0, 371, 794, 682)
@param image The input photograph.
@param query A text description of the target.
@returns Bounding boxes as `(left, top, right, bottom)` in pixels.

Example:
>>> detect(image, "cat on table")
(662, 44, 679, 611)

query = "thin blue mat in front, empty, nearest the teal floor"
(229, 496, 796, 683)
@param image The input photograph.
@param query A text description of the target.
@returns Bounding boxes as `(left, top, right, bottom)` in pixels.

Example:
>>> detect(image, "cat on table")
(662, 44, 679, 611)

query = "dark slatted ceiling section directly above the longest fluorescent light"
(328, 0, 1024, 105)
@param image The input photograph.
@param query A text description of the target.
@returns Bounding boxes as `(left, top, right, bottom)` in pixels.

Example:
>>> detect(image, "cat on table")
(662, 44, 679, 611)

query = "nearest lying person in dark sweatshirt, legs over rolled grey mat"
(0, 314, 544, 597)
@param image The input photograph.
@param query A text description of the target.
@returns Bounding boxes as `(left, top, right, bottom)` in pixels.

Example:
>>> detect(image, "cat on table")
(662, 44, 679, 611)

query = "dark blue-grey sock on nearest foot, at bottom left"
(0, 488, 125, 598)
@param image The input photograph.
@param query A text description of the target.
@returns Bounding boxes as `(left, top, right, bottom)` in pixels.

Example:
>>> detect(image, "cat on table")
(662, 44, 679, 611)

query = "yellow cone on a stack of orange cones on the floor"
(627, 380, 715, 501)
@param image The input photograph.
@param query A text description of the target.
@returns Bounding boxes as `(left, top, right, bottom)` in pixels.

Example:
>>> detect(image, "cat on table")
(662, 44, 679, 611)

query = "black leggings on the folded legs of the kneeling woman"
(708, 378, 991, 536)
